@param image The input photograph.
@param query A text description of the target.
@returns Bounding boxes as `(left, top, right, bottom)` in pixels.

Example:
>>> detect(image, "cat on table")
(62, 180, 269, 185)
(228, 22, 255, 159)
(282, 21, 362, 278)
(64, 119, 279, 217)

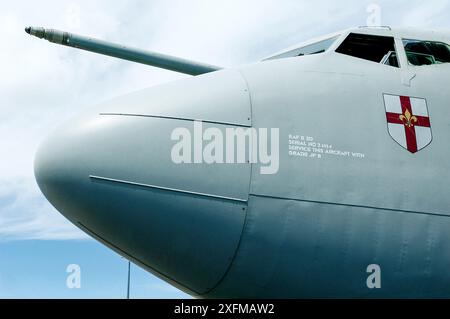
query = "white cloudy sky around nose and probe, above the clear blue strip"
(0, 0, 450, 239)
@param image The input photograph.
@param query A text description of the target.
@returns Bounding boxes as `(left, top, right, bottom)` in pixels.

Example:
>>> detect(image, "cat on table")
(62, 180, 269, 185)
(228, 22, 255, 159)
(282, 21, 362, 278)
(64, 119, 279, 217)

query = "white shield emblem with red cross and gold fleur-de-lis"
(383, 94, 433, 153)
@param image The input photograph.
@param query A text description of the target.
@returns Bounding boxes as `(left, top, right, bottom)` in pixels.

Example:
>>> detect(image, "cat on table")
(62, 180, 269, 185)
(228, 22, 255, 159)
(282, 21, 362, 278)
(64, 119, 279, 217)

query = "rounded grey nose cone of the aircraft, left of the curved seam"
(35, 71, 251, 295)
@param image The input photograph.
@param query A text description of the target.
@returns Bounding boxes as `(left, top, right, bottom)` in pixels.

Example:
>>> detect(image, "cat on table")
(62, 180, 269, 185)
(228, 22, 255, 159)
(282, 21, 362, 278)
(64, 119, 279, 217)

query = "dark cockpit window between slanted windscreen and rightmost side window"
(336, 33, 399, 68)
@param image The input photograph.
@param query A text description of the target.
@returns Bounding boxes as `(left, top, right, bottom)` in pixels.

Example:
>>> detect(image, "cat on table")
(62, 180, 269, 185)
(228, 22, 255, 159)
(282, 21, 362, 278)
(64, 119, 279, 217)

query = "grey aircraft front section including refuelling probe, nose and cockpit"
(26, 27, 450, 298)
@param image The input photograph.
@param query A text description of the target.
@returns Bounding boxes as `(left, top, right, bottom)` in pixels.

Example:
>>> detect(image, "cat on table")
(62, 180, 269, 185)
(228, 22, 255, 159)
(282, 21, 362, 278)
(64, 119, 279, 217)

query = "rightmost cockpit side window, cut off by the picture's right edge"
(403, 39, 450, 66)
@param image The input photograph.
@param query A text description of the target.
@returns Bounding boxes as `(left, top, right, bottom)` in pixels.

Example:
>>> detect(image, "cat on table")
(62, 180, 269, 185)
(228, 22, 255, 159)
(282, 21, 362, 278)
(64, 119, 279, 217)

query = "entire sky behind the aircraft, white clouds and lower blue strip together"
(0, 0, 450, 298)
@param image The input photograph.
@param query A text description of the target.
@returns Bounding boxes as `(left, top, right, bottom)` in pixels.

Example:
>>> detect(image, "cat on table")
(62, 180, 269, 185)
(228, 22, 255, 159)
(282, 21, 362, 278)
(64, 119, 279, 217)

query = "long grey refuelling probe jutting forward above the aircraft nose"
(25, 27, 221, 75)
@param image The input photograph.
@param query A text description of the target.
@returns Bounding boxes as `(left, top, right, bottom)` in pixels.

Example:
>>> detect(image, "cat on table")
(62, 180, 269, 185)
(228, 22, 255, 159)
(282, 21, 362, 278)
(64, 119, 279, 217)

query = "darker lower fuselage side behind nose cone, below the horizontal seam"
(203, 196, 450, 298)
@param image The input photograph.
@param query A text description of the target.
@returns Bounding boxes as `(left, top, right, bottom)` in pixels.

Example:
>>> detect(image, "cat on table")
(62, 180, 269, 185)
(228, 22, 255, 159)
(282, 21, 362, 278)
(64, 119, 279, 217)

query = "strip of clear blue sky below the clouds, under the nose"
(0, 240, 189, 299)
